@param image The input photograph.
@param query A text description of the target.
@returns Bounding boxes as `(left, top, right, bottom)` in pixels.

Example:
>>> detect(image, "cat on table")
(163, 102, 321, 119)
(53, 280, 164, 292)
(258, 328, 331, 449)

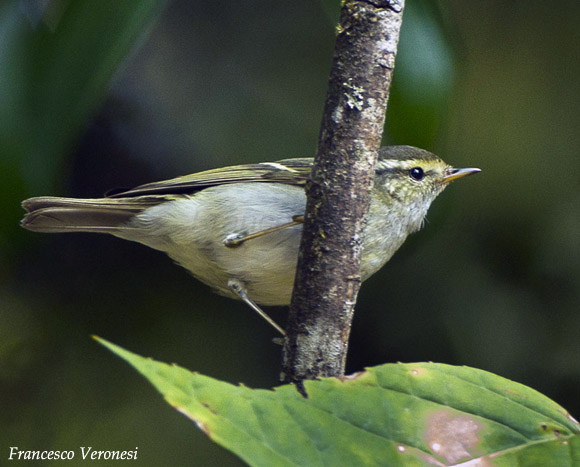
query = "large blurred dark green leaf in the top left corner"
(0, 0, 166, 194)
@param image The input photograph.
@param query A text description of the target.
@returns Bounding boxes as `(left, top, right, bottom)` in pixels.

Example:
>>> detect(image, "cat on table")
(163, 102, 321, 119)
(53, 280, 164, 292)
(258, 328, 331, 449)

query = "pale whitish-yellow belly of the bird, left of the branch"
(135, 184, 305, 305)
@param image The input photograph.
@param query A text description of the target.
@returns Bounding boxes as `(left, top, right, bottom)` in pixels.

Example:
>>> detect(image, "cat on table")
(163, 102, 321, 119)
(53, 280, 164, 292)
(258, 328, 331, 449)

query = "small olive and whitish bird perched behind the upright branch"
(21, 145, 480, 335)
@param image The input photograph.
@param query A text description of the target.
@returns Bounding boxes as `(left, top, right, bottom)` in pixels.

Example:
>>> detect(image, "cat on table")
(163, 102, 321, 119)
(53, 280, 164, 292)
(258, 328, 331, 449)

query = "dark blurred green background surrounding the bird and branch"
(0, 0, 580, 466)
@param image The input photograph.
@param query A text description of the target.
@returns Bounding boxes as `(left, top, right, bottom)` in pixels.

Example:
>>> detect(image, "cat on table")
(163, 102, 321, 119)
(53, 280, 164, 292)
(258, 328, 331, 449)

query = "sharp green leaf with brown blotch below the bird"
(98, 339, 580, 466)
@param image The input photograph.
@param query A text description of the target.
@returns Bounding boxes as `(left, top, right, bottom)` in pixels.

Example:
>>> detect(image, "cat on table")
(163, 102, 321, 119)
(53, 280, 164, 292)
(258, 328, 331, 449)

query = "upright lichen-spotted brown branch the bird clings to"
(283, 0, 404, 381)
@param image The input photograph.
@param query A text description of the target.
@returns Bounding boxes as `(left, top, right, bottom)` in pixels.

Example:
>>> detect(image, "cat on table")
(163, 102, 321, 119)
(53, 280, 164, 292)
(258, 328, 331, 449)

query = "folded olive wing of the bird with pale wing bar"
(108, 158, 312, 198)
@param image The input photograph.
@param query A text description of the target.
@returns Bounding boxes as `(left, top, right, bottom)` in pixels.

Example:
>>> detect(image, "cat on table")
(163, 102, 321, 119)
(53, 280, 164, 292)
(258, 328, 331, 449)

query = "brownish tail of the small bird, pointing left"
(21, 196, 161, 234)
